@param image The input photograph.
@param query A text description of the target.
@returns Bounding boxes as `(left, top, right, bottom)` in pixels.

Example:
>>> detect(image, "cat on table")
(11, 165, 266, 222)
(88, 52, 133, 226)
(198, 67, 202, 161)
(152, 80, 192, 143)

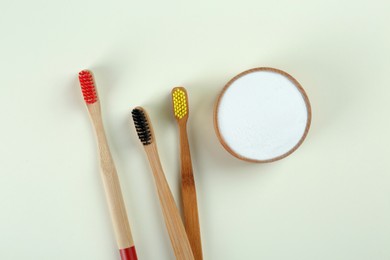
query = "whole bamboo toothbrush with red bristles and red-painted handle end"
(79, 70, 137, 260)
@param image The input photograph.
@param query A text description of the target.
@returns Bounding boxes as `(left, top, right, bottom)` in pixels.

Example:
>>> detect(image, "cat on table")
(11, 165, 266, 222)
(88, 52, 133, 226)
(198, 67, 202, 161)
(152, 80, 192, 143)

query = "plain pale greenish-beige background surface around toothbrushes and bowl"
(0, 0, 390, 260)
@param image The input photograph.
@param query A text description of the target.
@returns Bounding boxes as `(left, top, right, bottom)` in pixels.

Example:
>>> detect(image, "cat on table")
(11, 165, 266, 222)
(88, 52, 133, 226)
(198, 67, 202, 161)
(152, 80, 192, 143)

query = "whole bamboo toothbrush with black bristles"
(131, 107, 194, 260)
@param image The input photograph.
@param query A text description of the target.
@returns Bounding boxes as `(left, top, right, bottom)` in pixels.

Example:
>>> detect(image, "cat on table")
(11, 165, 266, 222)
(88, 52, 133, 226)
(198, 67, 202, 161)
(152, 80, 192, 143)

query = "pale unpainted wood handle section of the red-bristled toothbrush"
(87, 101, 134, 249)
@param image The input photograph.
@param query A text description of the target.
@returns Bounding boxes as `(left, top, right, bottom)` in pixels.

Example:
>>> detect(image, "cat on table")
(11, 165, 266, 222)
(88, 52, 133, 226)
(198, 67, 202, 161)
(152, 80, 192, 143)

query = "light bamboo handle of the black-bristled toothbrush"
(144, 143, 194, 260)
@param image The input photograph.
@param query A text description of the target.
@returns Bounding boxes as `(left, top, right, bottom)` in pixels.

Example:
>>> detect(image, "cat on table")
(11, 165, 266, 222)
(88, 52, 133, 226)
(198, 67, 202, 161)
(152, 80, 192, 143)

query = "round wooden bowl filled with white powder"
(214, 67, 312, 163)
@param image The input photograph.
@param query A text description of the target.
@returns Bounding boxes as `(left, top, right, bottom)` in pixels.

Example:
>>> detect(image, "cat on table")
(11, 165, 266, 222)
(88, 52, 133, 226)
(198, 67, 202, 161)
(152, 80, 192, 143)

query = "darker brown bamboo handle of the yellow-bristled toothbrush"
(179, 123, 203, 260)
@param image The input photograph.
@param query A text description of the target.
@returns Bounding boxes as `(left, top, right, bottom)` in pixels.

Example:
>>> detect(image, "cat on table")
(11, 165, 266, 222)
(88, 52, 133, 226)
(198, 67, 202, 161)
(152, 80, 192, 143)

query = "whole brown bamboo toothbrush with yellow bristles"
(172, 87, 203, 260)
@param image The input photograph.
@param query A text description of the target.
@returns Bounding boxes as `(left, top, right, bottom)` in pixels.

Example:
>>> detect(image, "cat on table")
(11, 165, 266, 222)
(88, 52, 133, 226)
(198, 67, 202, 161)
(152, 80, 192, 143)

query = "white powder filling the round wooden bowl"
(217, 71, 308, 160)
